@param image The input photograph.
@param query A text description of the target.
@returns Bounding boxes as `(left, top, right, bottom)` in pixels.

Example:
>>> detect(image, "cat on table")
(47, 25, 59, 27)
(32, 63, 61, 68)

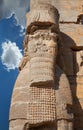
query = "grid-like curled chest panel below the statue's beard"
(27, 86, 56, 126)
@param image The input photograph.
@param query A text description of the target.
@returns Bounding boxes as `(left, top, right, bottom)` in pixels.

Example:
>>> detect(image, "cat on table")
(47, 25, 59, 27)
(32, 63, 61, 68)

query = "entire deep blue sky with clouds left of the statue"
(0, 0, 29, 130)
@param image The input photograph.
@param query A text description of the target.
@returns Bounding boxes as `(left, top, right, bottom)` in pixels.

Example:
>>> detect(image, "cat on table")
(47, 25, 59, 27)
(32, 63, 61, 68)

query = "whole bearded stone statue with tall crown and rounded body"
(9, 3, 73, 130)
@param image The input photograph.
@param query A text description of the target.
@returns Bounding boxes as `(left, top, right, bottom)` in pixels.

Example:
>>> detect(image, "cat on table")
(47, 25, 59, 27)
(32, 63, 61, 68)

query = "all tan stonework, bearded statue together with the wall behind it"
(9, 0, 83, 130)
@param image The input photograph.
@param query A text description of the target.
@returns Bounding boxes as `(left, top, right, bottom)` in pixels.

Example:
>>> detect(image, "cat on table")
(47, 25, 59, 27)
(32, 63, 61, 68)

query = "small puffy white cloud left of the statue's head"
(1, 41, 22, 71)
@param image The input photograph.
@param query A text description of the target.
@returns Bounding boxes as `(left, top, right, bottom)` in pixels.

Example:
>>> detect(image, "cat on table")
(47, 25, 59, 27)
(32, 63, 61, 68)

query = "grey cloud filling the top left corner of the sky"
(0, 0, 30, 26)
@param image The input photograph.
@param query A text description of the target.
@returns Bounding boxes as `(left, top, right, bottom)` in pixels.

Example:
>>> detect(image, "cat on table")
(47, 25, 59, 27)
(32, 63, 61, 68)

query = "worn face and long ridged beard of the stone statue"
(28, 34, 57, 86)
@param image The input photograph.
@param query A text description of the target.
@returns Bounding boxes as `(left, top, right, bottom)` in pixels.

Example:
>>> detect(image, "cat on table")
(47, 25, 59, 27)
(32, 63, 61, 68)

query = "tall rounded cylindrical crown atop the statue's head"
(26, 4, 59, 34)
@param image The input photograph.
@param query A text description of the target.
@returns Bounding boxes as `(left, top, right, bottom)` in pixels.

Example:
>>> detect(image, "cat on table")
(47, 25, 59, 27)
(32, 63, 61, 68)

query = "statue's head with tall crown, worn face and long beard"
(26, 4, 59, 86)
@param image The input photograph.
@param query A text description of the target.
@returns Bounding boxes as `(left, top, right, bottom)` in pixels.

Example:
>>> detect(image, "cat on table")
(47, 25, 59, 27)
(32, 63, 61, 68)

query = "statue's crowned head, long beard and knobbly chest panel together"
(24, 3, 59, 127)
